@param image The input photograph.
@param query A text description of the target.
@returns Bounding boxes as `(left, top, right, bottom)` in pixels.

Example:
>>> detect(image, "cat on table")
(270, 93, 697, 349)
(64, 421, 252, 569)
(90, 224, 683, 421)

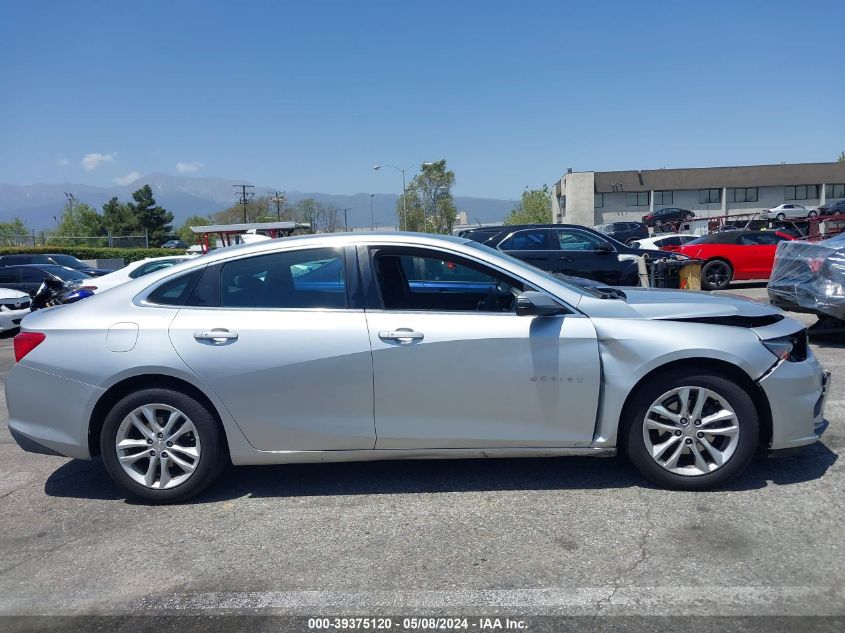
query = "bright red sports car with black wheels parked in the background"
(677, 231, 790, 290)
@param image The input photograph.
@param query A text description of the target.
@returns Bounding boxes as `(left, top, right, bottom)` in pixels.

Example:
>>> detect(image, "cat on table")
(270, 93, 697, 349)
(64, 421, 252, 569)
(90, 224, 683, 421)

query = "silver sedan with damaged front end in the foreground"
(6, 233, 828, 502)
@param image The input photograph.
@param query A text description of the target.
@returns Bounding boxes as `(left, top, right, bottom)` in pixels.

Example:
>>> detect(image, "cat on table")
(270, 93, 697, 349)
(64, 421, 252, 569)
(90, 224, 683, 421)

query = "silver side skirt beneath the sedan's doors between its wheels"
(232, 447, 616, 466)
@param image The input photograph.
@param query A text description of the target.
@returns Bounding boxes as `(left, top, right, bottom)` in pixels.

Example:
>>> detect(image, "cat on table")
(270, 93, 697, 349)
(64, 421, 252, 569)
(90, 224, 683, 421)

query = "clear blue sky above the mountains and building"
(0, 0, 845, 198)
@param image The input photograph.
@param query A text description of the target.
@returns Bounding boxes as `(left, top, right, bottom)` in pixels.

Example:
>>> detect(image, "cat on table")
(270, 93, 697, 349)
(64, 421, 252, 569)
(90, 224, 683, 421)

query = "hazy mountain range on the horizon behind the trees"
(0, 173, 516, 230)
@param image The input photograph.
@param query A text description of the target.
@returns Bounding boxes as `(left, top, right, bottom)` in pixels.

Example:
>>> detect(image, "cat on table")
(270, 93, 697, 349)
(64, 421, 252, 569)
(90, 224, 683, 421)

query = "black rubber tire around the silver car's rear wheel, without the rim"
(100, 388, 228, 503)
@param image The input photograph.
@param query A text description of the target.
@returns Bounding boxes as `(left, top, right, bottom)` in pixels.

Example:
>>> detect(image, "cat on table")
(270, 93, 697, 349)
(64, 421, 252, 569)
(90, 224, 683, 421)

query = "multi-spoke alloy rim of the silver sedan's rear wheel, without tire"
(115, 404, 202, 490)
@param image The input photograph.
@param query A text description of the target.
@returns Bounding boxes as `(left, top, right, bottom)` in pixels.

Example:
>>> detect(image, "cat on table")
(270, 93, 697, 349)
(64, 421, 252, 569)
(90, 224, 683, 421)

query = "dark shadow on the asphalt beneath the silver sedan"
(44, 443, 838, 503)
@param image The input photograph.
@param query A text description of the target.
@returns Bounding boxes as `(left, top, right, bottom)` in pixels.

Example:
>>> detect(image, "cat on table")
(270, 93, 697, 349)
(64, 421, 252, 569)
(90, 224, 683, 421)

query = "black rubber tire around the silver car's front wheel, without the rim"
(620, 368, 760, 490)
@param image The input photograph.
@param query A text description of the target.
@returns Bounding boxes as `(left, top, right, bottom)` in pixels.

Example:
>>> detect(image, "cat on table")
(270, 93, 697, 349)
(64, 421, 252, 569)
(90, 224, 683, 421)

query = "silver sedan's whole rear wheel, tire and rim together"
(100, 389, 226, 503)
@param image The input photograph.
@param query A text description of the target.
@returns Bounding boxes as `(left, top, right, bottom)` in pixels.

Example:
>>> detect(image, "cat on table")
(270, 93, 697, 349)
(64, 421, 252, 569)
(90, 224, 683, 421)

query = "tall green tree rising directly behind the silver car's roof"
(396, 159, 458, 235)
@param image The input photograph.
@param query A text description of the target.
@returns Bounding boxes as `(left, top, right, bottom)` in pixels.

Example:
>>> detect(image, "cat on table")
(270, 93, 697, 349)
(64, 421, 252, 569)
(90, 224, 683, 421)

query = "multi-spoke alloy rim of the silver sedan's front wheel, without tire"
(643, 386, 739, 477)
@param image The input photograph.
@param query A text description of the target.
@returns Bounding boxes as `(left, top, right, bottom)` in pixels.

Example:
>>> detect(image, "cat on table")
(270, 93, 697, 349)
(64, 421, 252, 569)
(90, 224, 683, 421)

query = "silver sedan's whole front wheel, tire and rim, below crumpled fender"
(622, 370, 760, 490)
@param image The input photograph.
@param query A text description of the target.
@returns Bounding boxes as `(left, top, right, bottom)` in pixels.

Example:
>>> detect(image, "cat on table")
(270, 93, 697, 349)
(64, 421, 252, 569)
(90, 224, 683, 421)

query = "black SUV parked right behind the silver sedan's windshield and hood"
(483, 224, 656, 286)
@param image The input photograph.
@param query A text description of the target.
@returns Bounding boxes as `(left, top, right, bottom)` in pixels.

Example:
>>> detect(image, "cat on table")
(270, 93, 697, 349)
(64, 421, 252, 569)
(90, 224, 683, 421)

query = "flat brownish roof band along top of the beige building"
(595, 162, 845, 193)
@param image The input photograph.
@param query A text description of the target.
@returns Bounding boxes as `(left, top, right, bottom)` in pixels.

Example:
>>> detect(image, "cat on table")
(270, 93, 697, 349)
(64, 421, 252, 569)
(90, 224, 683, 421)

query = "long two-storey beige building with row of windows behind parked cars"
(552, 163, 845, 226)
